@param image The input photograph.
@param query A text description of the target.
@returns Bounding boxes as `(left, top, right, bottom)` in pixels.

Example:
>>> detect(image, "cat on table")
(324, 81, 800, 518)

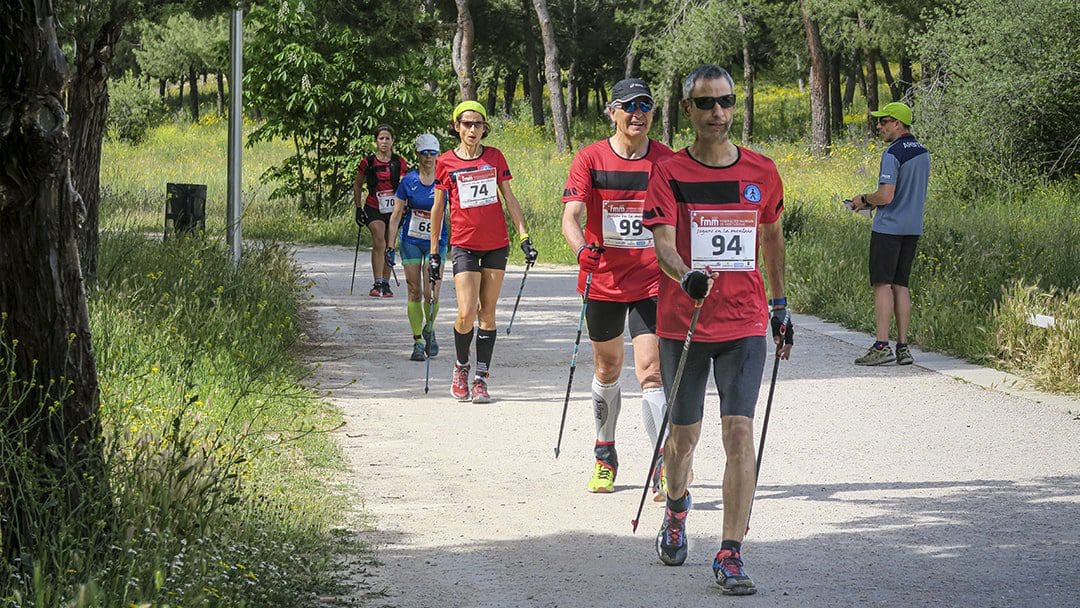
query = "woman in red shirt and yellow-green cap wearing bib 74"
(429, 102, 537, 403)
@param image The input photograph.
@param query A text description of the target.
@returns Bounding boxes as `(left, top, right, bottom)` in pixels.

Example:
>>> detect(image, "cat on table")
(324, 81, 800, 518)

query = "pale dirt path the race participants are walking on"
(297, 247, 1080, 608)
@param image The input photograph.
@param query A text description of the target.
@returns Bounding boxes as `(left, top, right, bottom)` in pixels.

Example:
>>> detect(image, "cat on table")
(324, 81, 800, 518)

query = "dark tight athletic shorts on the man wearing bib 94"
(660, 336, 765, 424)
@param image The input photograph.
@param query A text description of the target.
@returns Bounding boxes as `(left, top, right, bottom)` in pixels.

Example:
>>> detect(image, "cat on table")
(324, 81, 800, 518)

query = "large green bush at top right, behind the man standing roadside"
(915, 0, 1080, 187)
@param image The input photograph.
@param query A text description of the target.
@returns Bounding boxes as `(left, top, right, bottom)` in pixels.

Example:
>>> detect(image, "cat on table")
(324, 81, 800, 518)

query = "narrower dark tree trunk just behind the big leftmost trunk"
(68, 16, 120, 278)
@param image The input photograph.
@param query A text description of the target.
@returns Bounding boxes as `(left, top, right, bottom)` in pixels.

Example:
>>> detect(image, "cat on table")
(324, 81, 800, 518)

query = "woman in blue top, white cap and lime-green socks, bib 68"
(389, 133, 449, 361)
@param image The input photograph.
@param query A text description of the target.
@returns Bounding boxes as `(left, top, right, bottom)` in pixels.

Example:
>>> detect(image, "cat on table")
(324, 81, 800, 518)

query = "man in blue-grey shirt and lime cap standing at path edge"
(851, 102, 930, 365)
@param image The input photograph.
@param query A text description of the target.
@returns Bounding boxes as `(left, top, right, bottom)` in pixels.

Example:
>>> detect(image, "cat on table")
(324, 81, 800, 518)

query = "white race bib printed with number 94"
(690, 210, 757, 272)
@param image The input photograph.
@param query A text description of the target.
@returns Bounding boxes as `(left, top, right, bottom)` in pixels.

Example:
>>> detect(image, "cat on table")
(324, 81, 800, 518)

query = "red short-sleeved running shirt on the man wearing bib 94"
(644, 147, 784, 342)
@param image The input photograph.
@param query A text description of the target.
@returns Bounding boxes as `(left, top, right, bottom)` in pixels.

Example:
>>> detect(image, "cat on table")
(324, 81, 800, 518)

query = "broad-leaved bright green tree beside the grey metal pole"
(245, 0, 453, 216)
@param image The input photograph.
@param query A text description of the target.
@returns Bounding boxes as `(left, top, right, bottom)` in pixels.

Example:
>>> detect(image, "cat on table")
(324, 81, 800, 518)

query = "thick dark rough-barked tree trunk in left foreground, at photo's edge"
(0, 0, 110, 561)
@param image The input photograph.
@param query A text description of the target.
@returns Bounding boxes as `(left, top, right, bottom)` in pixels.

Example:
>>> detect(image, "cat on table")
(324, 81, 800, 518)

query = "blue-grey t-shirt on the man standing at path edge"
(874, 133, 930, 235)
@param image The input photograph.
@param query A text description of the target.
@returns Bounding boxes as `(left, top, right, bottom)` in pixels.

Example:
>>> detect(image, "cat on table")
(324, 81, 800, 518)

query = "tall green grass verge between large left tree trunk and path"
(0, 233, 355, 608)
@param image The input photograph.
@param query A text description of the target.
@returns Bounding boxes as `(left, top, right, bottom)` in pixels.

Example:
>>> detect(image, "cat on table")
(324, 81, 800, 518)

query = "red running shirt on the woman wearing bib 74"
(435, 146, 512, 252)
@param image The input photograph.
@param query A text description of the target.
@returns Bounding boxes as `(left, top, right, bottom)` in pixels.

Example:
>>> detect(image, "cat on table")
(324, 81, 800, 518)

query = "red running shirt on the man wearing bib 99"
(563, 139, 673, 302)
